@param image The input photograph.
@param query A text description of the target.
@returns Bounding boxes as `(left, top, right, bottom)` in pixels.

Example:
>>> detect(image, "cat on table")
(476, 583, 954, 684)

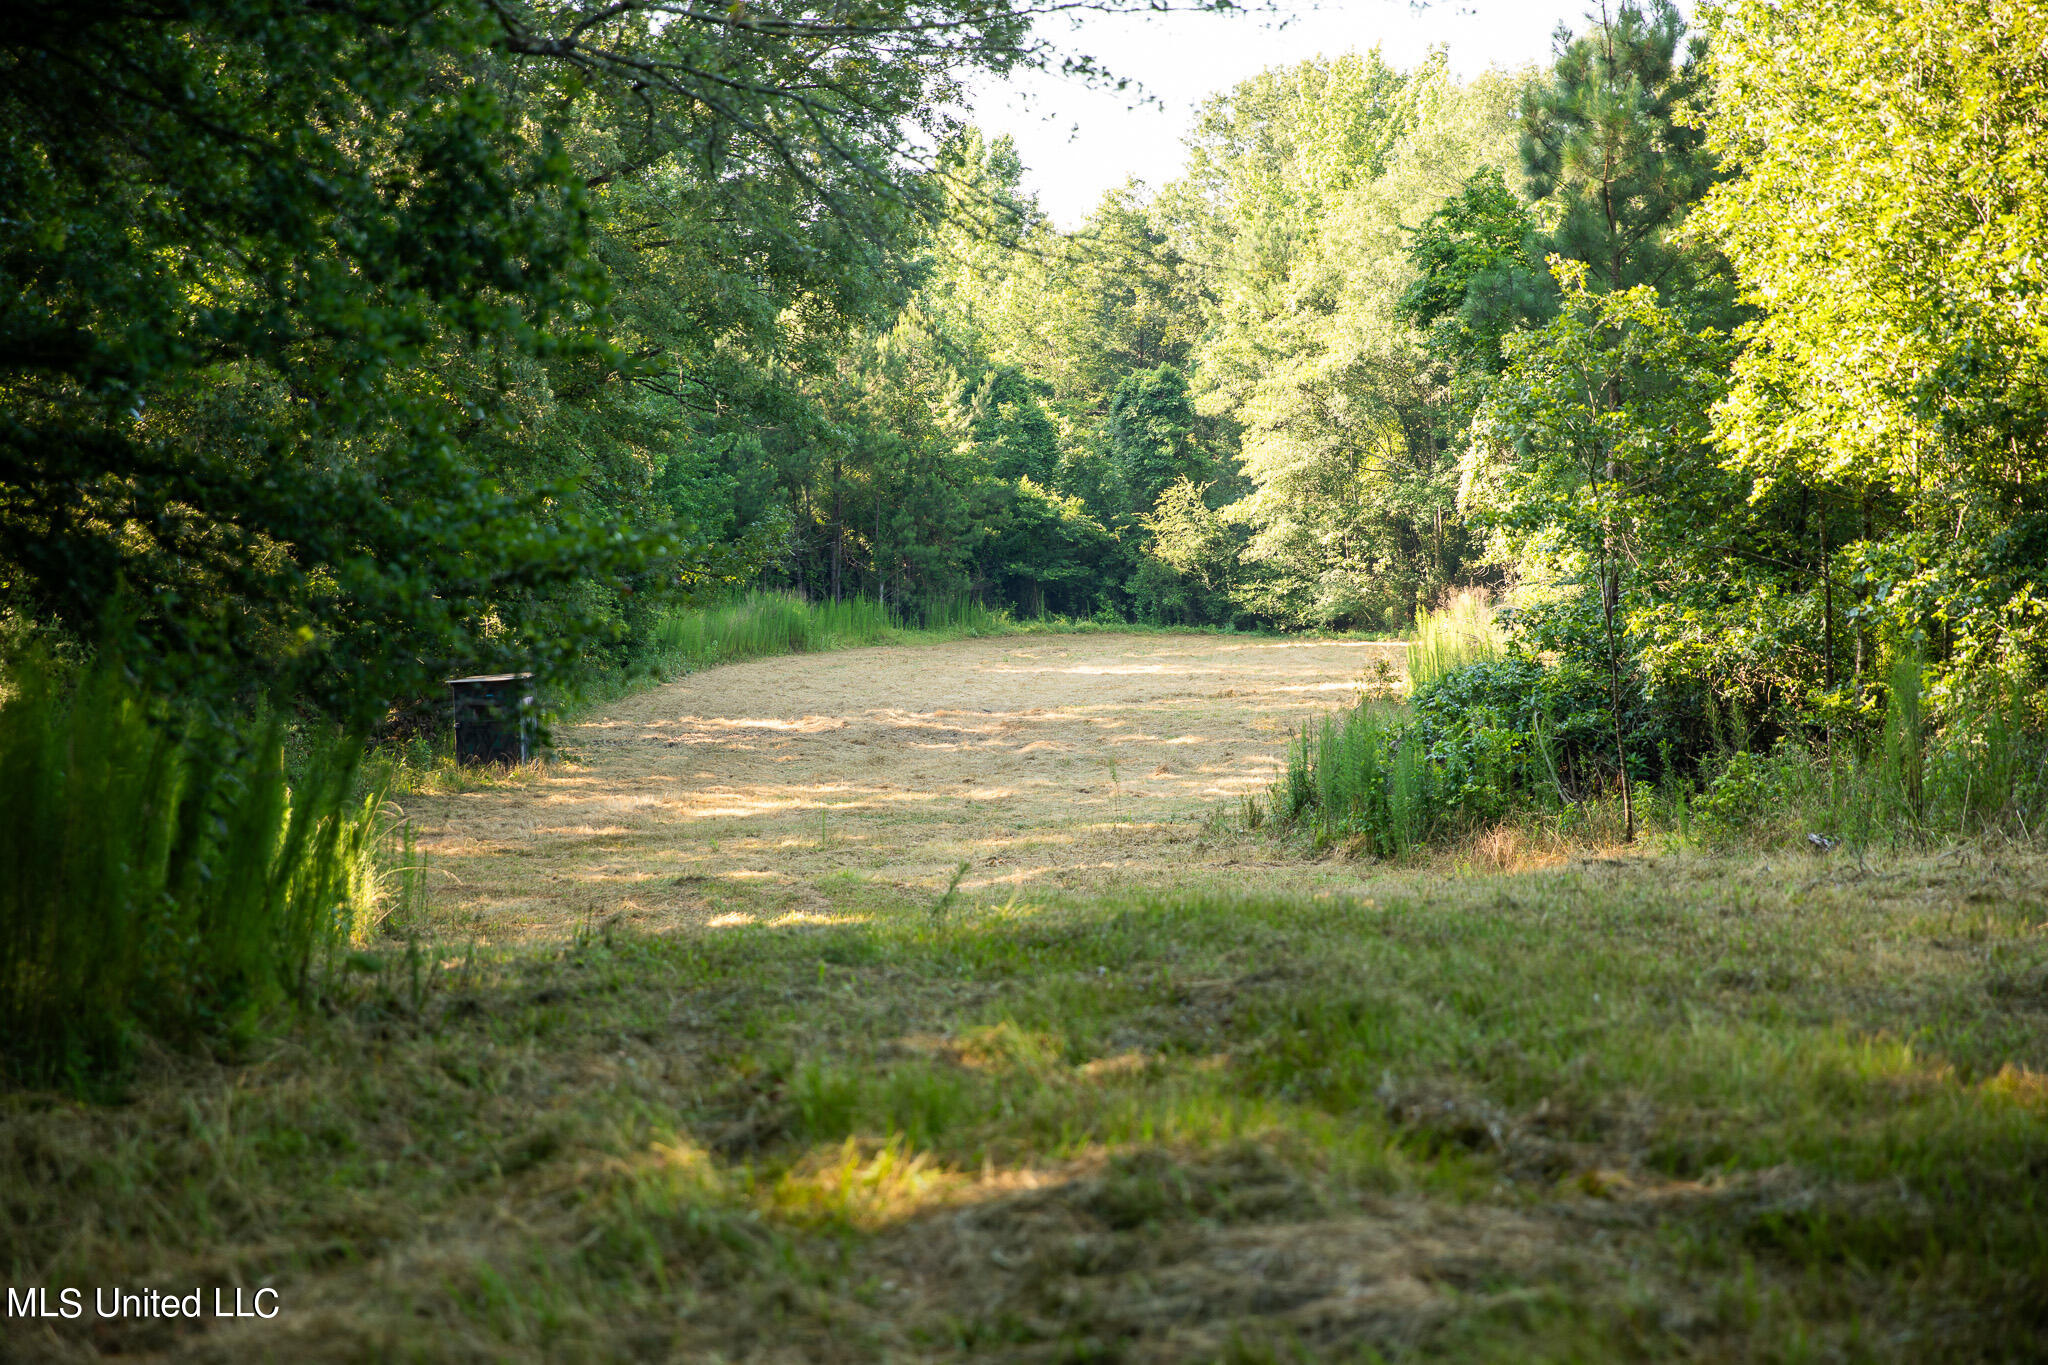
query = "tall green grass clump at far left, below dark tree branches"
(0, 663, 381, 1087)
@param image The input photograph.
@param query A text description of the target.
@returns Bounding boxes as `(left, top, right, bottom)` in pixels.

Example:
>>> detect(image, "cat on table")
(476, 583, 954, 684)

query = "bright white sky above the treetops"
(971, 0, 1646, 229)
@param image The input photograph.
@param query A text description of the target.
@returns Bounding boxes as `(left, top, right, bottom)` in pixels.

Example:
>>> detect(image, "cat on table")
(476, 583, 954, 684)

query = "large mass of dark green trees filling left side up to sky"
(0, 0, 1196, 716)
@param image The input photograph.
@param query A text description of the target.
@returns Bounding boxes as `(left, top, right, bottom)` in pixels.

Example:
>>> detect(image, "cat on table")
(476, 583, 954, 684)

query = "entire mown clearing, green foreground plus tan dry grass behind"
(0, 639, 2048, 1363)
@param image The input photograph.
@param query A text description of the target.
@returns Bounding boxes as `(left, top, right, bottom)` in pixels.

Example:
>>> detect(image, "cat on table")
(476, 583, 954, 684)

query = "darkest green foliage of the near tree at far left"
(0, 0, 659, 716)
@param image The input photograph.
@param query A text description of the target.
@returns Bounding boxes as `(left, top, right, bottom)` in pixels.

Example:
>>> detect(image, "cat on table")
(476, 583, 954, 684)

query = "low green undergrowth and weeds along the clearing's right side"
(1247, 638, 2048, 857)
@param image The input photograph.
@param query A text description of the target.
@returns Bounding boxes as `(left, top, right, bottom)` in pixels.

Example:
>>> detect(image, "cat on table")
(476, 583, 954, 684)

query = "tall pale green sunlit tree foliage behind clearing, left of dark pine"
(1161, 53, 1522, 628)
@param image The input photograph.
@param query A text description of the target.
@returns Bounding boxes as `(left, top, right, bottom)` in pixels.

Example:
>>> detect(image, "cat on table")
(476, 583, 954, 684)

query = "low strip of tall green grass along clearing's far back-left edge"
(649, 591, 1010, 669)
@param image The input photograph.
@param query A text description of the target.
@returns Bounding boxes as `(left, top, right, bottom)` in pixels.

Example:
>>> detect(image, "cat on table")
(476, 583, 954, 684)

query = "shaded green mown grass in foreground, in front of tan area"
(0, 849, 2048, 1361)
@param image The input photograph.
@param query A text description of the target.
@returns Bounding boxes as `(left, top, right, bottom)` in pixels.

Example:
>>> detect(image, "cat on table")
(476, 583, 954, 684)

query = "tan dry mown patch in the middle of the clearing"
(408, 634, 1403, 943)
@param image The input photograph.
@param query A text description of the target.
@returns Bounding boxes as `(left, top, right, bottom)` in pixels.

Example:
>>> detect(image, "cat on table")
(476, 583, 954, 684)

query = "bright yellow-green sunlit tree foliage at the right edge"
(1704, 0, 2048, 690)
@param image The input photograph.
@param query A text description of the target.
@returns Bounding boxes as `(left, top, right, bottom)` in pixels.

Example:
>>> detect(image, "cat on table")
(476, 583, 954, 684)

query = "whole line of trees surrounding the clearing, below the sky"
(0, 0, 2048, 749)
